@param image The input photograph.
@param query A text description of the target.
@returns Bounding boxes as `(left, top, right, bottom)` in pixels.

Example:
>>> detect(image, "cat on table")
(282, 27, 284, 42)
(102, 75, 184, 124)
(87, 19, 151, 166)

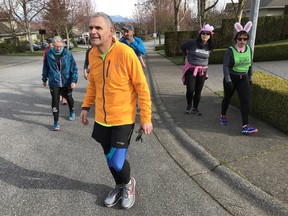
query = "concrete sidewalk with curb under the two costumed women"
(147, 49, 288, 215)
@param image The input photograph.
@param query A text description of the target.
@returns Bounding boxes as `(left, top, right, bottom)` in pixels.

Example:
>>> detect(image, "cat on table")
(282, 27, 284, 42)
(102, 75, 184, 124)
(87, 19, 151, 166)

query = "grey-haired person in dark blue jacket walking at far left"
(42, 36, 78, 131)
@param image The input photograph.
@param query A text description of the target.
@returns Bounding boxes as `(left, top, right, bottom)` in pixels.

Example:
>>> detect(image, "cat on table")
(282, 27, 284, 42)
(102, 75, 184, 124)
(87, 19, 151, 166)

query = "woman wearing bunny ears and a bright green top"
(220, 21, 258, 134)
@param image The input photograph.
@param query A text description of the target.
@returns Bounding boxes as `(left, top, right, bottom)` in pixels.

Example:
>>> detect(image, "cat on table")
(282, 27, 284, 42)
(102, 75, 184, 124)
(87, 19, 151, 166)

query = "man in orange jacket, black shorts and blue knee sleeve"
(80, 12, 153, 209)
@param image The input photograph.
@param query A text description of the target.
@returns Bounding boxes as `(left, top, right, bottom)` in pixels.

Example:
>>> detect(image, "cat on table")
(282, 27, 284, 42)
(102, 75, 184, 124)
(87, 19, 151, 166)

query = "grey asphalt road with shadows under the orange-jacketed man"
(0, 52, 231, 216)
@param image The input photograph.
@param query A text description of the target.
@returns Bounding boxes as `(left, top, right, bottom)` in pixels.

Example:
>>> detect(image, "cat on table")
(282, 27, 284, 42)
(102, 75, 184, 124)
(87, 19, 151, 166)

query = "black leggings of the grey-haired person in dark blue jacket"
(50, 87, 74, 121)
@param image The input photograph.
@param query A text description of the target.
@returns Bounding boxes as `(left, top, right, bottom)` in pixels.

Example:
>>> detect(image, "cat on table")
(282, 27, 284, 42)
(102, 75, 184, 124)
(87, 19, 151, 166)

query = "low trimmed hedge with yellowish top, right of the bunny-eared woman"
(231, 71, 288, 134)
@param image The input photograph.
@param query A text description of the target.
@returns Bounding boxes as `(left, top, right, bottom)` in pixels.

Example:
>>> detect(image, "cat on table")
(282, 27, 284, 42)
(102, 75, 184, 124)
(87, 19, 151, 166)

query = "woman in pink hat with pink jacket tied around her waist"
(180, 24, 214, 116)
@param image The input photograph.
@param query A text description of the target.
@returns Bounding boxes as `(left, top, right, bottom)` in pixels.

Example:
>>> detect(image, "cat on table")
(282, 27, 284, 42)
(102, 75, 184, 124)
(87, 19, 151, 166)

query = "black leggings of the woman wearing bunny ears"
(221, 74, 250, 125)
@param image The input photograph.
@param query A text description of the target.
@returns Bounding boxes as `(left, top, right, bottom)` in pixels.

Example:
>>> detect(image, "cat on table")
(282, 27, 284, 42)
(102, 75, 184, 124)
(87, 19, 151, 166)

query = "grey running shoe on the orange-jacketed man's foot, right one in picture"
(121, 177, 136, 209)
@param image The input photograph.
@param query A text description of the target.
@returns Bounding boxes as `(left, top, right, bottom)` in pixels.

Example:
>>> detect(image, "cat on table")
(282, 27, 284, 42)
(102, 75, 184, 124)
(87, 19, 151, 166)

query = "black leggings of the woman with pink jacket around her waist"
(185, 69, 206, 109)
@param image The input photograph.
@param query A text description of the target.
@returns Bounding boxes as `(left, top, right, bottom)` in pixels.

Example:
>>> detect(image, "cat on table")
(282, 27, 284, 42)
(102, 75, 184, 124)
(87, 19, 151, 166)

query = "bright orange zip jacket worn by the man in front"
(82, 38, 151, 125)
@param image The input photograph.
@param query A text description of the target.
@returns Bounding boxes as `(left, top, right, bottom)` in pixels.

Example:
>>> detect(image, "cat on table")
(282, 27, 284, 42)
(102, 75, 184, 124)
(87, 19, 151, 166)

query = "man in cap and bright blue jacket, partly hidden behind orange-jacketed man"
(120, 24, 146, 68)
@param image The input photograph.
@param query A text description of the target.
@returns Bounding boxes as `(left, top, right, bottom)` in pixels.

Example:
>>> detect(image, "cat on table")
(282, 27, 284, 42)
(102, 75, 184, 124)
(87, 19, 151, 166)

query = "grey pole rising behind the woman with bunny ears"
(249, 0, 260, 59)
